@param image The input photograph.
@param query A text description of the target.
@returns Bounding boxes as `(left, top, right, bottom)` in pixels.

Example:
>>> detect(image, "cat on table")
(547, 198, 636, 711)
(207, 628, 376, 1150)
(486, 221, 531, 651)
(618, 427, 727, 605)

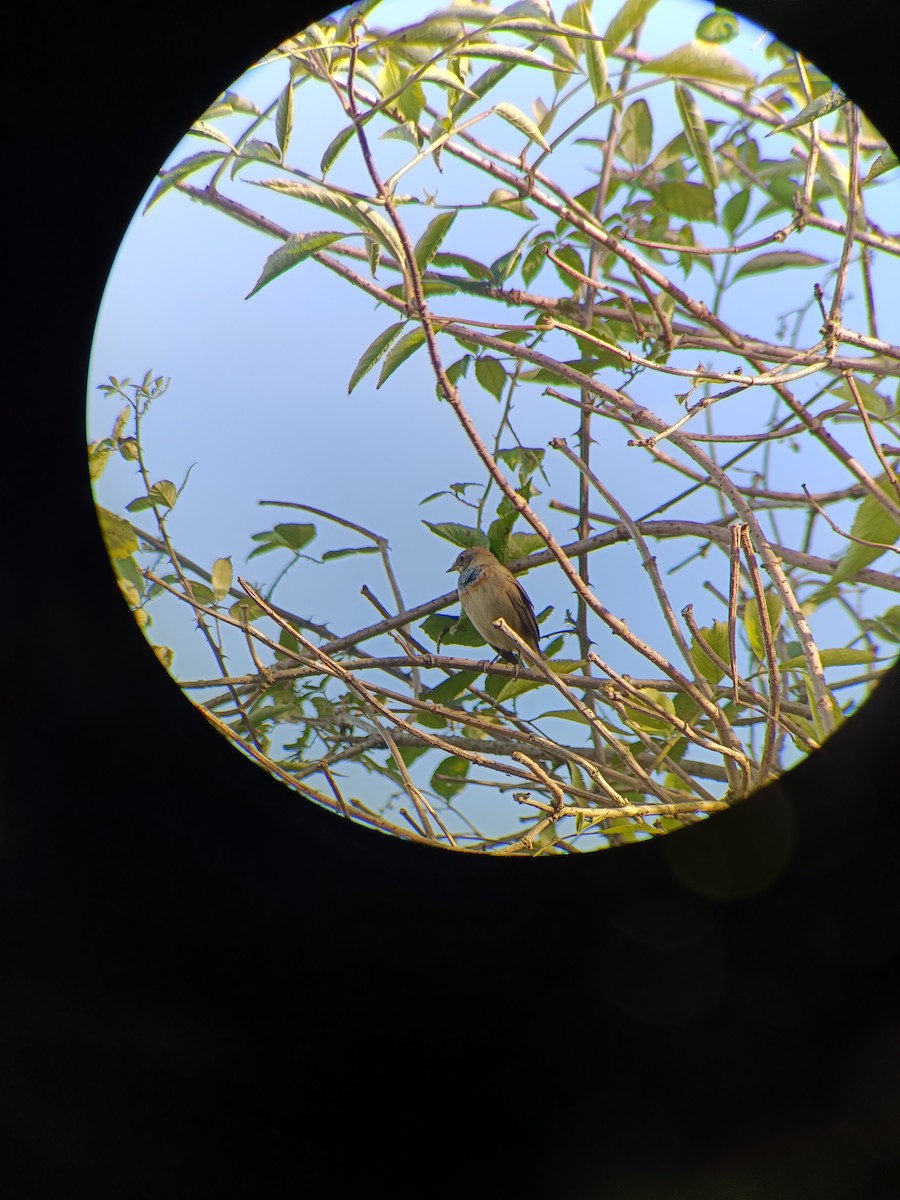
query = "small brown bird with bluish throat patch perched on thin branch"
(448, 546, 540, 662)
